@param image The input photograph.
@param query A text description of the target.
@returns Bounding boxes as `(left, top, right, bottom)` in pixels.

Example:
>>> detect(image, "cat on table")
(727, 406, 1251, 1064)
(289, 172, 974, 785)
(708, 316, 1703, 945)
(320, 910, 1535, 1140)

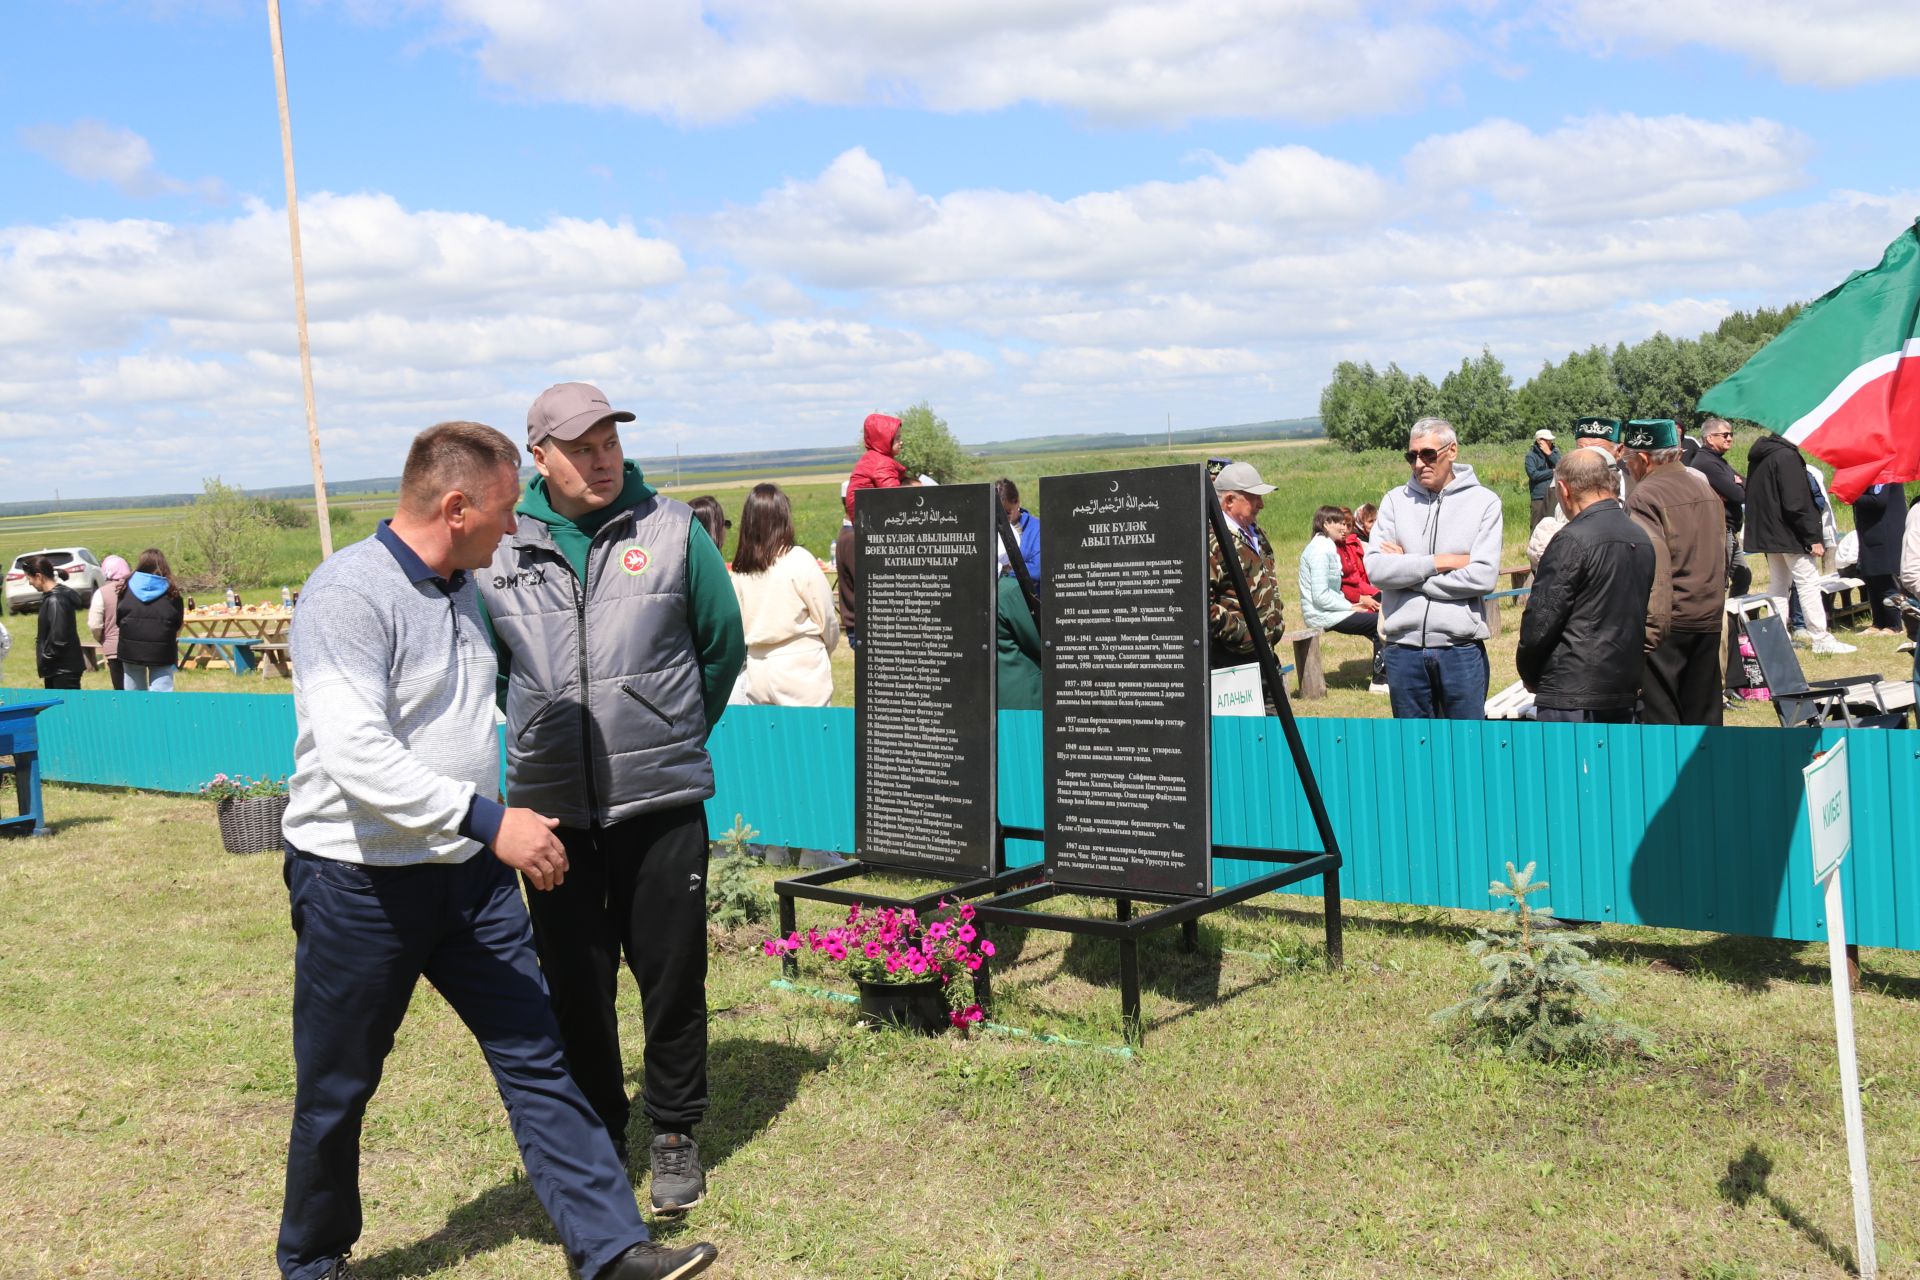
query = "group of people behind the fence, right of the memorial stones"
(1210, 415, 1920, 725)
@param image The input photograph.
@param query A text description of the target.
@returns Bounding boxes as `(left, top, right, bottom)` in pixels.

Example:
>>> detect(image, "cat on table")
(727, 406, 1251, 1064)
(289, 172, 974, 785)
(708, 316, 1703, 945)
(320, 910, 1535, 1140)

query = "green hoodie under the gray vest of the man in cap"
(480, 459, 747, 729)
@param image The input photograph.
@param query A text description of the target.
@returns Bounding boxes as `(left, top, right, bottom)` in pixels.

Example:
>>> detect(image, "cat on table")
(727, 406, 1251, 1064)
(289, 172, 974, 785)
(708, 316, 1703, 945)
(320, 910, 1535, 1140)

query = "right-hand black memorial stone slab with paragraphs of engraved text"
(1041, 464, 1213, 896)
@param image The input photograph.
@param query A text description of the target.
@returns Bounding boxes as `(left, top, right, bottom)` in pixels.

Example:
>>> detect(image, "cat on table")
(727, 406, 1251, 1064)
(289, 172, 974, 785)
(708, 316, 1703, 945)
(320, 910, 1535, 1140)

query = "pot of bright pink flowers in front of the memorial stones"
(762, 902, 993, 1034)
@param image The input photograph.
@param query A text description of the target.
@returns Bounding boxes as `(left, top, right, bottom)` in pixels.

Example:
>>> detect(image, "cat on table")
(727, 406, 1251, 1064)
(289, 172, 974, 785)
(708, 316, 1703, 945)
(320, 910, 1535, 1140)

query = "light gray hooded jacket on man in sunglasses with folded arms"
(1367, 462, 1503, 649)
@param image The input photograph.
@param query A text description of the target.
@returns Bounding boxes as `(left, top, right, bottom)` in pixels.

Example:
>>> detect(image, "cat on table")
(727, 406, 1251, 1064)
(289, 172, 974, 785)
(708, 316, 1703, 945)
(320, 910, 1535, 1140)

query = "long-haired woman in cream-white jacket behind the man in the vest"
(733, 484, 839, 706)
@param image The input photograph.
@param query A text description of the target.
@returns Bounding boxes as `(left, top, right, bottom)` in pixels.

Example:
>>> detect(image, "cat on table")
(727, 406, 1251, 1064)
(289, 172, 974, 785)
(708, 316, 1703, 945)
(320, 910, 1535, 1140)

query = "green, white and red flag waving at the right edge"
(1699, 223, 1920, 503)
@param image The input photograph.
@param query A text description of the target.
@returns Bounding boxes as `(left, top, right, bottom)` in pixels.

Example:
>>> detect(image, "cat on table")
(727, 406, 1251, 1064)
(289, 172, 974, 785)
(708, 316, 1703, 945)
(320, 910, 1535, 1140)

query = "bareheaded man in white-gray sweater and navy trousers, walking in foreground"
(278, 422, 714, 1280)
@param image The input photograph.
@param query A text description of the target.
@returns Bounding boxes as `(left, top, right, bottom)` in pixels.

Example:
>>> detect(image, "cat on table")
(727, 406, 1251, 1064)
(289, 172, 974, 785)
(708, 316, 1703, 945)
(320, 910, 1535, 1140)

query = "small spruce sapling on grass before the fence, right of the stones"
(1434, 862, 1649, 1061)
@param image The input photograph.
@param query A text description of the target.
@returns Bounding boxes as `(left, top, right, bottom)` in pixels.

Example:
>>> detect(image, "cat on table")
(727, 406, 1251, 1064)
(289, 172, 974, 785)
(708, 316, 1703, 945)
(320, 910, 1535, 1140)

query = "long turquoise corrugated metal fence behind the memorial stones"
(11, 689, 1920, 950)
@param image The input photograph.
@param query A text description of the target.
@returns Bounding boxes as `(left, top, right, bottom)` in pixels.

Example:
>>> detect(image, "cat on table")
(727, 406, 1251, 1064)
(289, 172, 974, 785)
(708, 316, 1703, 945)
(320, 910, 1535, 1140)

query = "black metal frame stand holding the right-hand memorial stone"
(973, 486, 1346, 1044)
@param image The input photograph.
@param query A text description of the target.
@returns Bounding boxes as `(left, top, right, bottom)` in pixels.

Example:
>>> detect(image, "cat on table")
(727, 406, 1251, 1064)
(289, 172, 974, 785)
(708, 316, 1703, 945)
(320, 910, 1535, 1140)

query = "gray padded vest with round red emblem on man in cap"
(476, 495, 714, 827)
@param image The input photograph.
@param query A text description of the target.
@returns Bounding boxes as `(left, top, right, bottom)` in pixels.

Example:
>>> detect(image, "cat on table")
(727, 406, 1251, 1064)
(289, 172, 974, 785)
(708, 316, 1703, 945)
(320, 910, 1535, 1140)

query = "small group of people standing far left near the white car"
(21, 547, 186, 693)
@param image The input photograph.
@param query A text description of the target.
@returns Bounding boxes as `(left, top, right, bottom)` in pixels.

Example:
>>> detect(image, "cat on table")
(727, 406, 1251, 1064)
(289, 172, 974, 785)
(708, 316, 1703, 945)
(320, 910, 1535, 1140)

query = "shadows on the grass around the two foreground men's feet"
(355, 1038, 828, 1280)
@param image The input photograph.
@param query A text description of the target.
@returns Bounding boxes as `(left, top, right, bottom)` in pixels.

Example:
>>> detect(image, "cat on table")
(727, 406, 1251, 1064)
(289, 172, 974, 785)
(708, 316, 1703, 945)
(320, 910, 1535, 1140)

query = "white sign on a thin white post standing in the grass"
(1801, 739, 1878, 1280)
